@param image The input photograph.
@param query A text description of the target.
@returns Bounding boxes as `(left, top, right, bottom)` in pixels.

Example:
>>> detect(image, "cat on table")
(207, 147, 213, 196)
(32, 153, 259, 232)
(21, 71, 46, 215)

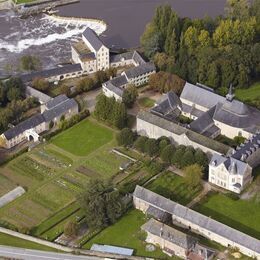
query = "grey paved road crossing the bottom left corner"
(0, 246, 100, 260)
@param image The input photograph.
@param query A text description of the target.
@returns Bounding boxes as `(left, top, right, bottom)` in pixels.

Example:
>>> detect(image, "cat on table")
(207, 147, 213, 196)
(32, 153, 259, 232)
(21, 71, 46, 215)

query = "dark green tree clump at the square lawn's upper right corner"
(94, 94, 127, 129)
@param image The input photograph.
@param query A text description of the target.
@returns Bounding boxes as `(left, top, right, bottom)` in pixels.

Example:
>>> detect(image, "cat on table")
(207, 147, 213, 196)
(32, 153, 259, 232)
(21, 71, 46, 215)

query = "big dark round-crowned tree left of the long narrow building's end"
(80, 179, 125, 228)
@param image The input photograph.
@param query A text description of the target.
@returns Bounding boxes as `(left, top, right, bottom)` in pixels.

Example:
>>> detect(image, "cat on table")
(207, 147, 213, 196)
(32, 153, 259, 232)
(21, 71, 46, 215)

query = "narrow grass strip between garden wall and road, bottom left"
(0, 233, 58, 252)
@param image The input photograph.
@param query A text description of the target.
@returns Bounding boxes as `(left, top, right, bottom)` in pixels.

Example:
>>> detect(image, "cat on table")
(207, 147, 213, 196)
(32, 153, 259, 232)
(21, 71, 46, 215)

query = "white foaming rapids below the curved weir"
(0, 11, 106, 70)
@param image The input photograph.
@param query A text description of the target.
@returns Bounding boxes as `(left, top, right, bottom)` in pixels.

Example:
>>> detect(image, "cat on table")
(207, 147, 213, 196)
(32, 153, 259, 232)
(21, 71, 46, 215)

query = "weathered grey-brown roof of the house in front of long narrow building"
(141, 219, 197, 250)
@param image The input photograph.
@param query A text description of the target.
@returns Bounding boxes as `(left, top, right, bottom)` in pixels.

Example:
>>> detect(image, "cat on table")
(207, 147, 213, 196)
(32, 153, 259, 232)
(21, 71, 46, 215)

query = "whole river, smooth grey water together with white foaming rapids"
(0, 0, 226, 71)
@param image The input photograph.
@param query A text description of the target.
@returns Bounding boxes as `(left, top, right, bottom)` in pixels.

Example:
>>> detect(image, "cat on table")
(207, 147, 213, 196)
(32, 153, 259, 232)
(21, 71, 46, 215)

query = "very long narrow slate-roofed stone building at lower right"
(133, 186, 260, 259)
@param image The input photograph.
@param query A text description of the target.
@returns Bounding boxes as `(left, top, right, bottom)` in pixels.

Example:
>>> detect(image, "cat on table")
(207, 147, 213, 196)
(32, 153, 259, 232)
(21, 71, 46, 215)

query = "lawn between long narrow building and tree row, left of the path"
(147, 172, 201, 205)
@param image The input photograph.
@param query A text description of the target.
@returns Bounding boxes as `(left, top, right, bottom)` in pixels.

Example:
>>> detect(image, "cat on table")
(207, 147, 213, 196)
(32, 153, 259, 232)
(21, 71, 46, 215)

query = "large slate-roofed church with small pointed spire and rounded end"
(180, 82, 260, 138)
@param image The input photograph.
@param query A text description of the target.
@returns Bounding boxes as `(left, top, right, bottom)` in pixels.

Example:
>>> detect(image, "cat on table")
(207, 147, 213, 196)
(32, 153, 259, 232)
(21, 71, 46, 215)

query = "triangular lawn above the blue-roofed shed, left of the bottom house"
(83, 210, 174, 259)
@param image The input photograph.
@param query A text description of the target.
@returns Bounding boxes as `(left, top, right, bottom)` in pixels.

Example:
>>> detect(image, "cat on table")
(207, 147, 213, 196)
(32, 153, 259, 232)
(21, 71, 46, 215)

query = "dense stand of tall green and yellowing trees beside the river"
(141, 0, 260, 91)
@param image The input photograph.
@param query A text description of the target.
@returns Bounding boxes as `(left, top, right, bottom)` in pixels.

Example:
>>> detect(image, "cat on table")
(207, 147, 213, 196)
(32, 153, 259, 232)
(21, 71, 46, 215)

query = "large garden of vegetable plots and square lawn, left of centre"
(0, 118, 128, 238)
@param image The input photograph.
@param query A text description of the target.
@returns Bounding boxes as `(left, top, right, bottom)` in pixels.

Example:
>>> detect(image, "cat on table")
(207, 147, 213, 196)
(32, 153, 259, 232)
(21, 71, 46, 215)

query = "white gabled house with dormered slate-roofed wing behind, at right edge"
(208, 133, 260, 193)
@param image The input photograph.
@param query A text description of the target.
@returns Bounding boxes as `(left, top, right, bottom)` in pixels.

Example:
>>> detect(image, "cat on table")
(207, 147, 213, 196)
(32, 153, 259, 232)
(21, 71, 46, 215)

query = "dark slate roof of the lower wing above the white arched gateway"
(4, 114, 44, 140)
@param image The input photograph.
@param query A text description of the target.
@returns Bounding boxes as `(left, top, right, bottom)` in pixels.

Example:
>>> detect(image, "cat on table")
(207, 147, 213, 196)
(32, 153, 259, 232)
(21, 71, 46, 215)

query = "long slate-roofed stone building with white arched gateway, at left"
(0, 95, 78, 149)
